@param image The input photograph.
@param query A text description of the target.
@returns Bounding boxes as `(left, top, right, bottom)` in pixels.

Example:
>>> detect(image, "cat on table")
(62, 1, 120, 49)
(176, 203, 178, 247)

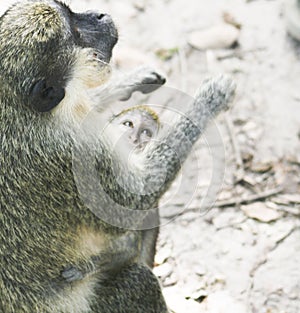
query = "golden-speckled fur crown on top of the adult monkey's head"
(0, 0, 69, 45)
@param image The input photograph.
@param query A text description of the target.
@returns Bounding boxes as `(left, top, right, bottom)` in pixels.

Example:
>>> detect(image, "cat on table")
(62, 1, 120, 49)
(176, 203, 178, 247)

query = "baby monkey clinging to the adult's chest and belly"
(61, 105, 160, 282)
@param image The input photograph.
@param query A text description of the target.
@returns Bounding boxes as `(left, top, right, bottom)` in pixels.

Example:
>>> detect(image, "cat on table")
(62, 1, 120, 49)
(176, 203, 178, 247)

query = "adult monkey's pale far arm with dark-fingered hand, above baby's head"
(91, 67, 166, 108)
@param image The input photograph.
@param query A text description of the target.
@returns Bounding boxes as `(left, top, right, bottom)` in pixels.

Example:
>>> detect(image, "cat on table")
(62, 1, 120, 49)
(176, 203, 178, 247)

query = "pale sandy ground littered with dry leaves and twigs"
(1, 0, 300, 313)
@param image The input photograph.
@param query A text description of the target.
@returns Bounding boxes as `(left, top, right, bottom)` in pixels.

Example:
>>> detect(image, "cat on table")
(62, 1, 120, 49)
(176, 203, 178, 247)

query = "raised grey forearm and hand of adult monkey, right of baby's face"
(143, 76, 236, 203)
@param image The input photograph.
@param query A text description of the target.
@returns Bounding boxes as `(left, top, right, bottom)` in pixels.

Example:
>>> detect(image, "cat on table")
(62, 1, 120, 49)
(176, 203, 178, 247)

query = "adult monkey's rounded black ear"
(29, 79, 65, 112)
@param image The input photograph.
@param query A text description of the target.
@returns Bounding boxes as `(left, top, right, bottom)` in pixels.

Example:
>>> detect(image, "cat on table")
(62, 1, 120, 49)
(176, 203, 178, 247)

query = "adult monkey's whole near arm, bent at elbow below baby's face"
(98, 76, 235, 214)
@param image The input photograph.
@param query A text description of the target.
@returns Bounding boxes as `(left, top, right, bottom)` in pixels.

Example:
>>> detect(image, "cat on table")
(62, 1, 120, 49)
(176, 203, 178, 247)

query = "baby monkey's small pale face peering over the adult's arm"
(112, 109, 159, 150)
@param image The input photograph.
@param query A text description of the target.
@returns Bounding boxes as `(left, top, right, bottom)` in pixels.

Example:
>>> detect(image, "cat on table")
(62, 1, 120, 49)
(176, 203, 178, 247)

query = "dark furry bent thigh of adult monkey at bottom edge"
(91, 264, 168, 313)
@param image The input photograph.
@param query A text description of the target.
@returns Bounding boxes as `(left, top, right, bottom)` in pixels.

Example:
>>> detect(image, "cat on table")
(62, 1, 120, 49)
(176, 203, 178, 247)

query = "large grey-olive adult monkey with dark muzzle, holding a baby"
(0, 0, 234, 313)
